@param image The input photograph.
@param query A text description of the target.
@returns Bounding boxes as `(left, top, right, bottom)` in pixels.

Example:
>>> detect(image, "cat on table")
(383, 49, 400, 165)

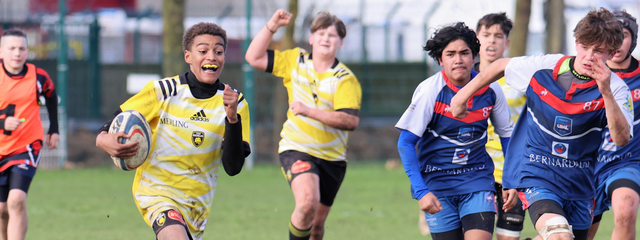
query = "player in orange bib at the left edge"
(0, 29, 60, 239)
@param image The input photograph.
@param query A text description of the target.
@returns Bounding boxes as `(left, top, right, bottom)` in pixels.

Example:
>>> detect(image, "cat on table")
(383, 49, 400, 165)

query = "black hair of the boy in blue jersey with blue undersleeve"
(423, 22, 480, 62)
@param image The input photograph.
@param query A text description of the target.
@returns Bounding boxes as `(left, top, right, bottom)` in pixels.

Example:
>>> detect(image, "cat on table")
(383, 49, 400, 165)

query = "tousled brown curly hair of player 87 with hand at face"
(573, 7, 624, 51)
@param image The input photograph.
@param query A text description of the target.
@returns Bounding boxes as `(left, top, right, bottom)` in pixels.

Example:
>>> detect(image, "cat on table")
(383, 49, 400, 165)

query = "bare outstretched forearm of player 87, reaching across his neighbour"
(450, 58, 511, 118)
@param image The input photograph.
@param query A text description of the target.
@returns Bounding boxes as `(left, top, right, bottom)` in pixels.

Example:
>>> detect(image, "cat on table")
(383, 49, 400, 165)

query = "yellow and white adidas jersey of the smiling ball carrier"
(120, 74, 249, 239)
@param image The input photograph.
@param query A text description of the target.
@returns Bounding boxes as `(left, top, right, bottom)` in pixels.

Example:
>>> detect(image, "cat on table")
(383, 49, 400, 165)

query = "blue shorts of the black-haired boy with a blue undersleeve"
(425, 191, 496, 233)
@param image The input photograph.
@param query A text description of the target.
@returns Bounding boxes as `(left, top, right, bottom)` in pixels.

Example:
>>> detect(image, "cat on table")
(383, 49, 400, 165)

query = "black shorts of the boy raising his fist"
(280, 150, 347, 207)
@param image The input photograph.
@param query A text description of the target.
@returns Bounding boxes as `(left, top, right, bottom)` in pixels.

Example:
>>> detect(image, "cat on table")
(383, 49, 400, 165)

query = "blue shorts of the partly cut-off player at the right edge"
(594, 167, 640, 215)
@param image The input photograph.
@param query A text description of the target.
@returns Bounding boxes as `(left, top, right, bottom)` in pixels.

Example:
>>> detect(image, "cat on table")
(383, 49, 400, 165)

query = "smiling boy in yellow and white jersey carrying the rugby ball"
(96, 23, 251, 240)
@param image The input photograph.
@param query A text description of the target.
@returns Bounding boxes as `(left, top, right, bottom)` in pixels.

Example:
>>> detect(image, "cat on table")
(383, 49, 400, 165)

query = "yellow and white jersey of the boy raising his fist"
(267, 48, 362, 161)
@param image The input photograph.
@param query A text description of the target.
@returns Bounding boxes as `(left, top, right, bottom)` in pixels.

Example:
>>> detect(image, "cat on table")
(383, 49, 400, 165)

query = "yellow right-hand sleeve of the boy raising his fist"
(333, 75, 362, 110)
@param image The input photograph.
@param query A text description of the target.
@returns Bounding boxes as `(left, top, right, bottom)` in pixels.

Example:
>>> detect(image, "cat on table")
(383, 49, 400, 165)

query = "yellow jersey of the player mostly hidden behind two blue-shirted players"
(486, 77, 527, 184)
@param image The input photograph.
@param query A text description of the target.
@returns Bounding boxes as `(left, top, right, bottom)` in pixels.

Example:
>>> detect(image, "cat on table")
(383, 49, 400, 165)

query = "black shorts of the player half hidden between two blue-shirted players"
(495, 183, 525, 232)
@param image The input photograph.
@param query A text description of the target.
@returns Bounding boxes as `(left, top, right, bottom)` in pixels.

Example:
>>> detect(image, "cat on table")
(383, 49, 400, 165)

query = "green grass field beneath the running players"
(27, 163, 636, 240)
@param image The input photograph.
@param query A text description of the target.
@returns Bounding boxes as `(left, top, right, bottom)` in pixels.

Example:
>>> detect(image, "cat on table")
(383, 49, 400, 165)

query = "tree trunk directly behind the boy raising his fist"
(272, 0, 298, 163)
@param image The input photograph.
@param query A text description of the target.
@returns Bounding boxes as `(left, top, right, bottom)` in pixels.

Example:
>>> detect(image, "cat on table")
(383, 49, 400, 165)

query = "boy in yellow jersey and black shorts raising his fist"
(245, 9, 362, 239)
